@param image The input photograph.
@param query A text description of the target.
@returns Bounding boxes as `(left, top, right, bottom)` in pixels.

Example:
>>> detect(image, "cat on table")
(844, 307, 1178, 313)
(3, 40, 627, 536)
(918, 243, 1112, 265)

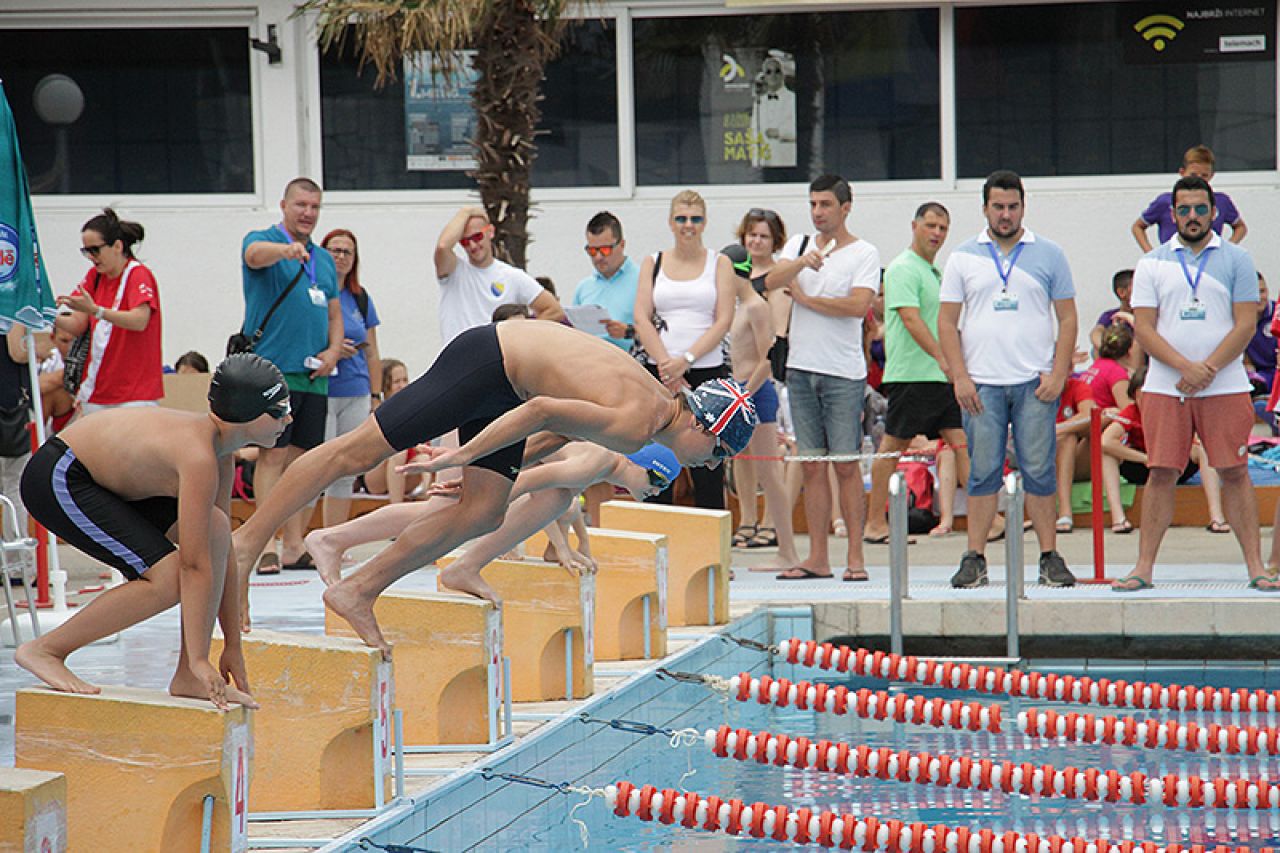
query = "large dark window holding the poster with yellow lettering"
(634, 9, 941, 184)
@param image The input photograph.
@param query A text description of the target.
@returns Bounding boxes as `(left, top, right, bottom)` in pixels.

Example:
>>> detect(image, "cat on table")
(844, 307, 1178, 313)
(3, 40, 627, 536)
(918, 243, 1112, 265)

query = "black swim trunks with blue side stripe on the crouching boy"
(22, 438, 178, 580)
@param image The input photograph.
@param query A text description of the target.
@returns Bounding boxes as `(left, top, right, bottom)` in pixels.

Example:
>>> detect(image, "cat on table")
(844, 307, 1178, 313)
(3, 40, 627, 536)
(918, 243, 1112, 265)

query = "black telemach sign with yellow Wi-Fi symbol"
(1119, 0, 1276, 65)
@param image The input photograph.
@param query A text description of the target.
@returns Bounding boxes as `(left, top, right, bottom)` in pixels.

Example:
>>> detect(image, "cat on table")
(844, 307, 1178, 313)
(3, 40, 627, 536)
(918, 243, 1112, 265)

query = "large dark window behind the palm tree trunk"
(320, 20, 618, 190)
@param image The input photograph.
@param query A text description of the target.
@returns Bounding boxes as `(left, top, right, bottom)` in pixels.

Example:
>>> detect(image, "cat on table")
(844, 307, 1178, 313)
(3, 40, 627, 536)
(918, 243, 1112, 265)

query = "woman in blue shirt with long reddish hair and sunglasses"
(320, 228, 383, 526)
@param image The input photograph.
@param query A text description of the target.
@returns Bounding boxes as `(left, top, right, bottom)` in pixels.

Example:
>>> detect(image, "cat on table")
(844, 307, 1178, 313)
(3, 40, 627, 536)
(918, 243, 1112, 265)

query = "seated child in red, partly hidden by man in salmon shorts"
(1102, 369, 1231, 550)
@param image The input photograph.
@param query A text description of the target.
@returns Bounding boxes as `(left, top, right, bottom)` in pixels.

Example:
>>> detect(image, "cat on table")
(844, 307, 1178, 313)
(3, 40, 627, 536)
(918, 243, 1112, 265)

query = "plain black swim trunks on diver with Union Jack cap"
(374, 325, 525, 480)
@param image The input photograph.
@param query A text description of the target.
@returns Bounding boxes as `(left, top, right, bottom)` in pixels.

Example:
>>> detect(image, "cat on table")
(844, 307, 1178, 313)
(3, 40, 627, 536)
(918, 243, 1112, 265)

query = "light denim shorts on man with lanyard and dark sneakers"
(964, 378, 1057, 497)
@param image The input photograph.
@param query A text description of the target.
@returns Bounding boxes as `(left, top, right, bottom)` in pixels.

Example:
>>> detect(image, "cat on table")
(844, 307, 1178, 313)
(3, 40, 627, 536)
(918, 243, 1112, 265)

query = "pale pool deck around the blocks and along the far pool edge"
(0, 528, 1280, 849)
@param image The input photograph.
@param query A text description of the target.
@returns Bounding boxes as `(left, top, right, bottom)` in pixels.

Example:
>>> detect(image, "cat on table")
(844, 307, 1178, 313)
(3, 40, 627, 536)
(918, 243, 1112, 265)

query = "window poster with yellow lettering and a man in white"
(703, 38, 796, 174)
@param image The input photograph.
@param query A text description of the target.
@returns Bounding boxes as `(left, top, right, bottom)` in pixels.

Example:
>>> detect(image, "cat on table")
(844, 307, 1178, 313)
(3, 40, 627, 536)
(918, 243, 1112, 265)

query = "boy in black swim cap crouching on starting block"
(14, 353, 291, 708)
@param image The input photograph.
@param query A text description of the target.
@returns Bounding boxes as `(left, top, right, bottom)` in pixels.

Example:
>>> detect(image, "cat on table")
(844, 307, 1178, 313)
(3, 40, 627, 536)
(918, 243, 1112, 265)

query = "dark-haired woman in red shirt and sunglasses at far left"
(58, 207, 164, 414)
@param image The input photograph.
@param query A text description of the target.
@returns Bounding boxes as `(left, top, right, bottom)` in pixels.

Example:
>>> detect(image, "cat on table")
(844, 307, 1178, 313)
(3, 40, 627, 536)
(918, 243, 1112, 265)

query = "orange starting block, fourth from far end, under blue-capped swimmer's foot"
(325, 590, 502, 745)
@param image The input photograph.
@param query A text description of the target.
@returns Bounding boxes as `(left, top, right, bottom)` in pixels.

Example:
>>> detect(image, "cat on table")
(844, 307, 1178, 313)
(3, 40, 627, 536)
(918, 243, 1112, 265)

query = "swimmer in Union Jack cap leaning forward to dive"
(233, 323, 756, 656)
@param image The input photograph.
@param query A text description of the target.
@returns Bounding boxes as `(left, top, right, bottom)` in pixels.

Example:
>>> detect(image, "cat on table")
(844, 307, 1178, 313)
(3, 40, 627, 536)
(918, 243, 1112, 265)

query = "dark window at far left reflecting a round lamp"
(0, 27, 253, 195)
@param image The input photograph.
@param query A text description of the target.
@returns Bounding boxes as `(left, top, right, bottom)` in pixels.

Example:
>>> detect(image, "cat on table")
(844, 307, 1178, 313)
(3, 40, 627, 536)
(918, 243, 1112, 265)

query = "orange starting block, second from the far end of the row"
(525, 528, 667, 661)
